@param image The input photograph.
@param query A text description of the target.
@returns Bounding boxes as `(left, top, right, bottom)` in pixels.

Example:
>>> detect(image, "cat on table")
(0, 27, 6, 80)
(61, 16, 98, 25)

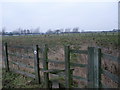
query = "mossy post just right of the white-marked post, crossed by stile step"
(43, 44, 49, 88)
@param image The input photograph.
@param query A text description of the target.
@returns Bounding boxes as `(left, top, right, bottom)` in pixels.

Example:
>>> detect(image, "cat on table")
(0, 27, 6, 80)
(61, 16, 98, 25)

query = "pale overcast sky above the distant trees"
(2, 2, 118, 32)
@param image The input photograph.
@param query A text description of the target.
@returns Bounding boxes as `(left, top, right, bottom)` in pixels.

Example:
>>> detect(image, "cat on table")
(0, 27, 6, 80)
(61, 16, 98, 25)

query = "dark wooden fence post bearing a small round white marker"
(34, 45, 40, 84)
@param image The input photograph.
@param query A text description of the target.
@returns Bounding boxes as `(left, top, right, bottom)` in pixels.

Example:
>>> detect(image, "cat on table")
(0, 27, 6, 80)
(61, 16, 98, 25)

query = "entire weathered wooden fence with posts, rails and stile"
(4, 43, 120, 88)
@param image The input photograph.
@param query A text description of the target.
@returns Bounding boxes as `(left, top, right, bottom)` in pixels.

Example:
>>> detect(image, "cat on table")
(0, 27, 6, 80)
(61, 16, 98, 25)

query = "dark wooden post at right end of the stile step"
(65, 46, 71, 88)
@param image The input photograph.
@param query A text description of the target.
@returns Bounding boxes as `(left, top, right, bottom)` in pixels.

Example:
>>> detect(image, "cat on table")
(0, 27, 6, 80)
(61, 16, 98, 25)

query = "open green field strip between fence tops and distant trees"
(2, 32, 120, 55)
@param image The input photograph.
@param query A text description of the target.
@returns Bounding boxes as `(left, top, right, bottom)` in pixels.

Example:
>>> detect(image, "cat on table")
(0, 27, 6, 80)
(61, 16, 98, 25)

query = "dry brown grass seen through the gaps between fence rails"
(4, 45, 120, 88)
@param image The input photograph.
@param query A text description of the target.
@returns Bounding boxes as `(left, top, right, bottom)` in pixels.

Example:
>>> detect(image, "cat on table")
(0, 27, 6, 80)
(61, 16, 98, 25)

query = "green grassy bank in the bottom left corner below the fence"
(2, 69, 43, 88)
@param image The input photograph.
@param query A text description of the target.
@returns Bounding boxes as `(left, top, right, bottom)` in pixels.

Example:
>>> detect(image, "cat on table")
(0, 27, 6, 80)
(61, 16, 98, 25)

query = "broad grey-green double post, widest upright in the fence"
(88, 47, 101, 88)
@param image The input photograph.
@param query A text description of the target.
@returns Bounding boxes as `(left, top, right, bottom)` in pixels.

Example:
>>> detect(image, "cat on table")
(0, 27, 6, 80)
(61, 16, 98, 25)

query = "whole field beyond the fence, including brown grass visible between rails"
(2, 33, 120, 87)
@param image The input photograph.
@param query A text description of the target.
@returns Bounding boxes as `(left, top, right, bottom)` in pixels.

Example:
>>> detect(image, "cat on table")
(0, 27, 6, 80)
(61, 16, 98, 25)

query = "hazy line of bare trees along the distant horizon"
(0, 27, 120, 36)
